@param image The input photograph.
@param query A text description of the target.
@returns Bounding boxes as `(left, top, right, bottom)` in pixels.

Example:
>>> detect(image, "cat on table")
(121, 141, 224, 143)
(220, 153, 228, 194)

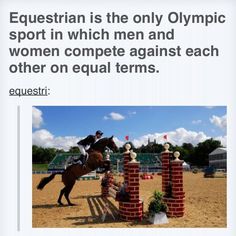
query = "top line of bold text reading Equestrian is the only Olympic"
(10, 12, 226, 26)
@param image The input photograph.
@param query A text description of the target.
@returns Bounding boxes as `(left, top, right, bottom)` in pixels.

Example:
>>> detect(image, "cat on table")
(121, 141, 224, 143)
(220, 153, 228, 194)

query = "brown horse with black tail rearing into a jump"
(37, 136, 118, 206)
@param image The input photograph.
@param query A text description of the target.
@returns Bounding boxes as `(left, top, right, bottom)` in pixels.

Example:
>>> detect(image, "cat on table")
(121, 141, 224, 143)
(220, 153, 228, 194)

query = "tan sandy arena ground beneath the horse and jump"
(32, 173, 227, 228)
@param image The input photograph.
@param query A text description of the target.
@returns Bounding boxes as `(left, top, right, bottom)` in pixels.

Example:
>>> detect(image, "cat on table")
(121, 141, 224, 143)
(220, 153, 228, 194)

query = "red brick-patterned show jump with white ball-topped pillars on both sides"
(101, 144, 185, 221)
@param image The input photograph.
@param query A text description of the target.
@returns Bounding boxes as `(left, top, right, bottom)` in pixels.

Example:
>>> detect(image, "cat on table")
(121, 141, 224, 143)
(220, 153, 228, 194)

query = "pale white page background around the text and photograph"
(0, 0, 236, 236)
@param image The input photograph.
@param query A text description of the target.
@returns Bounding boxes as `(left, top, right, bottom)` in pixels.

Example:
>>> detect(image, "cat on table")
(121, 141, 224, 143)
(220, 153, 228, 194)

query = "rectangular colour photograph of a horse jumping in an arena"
(32, 106, 227, 228)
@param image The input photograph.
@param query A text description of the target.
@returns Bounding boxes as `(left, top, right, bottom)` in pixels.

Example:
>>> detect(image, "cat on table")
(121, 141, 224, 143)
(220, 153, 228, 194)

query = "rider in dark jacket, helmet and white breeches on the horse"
(77, 130, 103, 165)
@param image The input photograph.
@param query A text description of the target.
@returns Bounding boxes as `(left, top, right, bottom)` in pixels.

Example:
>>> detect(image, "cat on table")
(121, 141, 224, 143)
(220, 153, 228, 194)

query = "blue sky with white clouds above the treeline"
(32, 106, 227, 150)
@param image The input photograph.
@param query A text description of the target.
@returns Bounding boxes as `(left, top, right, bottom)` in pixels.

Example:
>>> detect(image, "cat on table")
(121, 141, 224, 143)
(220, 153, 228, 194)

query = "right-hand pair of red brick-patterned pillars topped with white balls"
(161, 144, 185, 217)
